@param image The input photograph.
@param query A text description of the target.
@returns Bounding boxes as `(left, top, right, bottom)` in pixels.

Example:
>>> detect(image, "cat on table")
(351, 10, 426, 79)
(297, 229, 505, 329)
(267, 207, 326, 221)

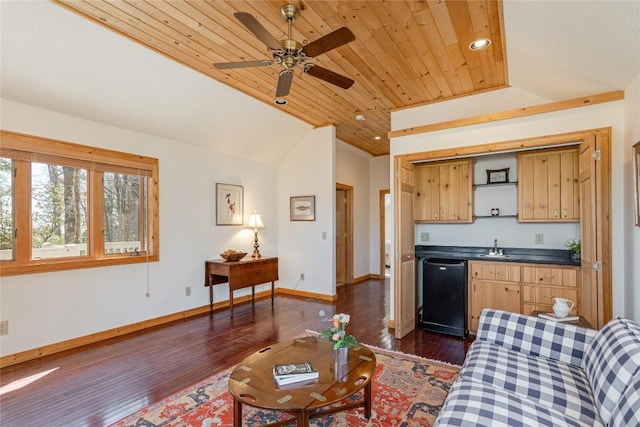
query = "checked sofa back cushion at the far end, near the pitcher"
(583, 318, 640, 424)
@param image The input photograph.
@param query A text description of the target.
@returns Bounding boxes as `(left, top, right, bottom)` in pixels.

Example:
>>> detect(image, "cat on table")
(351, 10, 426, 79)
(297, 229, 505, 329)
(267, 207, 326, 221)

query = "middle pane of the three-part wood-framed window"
(31, 163, 87, 259)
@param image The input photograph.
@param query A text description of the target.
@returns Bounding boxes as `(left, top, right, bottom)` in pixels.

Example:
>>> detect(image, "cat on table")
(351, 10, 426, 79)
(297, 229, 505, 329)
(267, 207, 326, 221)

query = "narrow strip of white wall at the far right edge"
(620, 74, 640, 320)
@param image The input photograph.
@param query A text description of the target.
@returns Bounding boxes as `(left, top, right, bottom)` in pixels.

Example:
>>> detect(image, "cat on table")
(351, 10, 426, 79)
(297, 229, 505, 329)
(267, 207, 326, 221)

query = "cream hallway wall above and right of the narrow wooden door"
(336, 141, 376, 278)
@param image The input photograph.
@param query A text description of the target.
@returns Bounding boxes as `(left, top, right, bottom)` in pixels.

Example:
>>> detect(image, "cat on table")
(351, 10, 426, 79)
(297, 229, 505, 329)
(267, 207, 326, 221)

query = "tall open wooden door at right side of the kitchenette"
(579, 130, 612, 328)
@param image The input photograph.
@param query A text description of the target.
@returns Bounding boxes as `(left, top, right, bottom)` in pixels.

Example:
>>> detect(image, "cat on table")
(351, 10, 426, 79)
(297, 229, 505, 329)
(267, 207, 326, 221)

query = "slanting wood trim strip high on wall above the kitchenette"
(387, 90, 624, 140)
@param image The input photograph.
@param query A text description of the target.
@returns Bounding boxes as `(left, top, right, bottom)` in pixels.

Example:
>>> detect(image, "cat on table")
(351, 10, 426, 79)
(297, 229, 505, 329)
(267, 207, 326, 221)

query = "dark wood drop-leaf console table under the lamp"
(204, 257, 278, 317)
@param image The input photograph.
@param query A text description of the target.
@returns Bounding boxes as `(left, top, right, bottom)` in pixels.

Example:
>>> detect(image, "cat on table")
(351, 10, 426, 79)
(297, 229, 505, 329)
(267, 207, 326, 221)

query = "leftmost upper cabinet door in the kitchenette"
(415, 165, 440, 221)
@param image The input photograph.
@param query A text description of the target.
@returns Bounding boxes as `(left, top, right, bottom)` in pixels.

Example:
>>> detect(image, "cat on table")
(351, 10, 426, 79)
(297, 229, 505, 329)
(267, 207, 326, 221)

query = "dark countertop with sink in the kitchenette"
(415, 245, 580, 267)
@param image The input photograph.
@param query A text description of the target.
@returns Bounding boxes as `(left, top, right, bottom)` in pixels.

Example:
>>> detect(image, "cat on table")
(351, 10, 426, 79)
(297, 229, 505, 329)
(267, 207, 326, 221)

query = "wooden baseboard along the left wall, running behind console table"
(0, 288, 337, 368)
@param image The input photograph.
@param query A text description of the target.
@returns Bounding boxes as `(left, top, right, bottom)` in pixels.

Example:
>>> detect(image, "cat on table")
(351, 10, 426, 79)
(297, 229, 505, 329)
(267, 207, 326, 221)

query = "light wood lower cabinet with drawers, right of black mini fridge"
(467, 261, 580, 334)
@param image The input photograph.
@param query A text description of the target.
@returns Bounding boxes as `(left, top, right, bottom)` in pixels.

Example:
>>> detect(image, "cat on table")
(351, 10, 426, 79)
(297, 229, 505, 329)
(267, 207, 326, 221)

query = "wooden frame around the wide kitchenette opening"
(390, 127, 613, 327)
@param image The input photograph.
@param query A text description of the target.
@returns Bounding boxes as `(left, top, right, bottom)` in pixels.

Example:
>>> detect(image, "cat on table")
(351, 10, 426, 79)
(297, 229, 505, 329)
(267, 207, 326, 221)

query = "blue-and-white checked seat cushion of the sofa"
(460, 341, 600, 425)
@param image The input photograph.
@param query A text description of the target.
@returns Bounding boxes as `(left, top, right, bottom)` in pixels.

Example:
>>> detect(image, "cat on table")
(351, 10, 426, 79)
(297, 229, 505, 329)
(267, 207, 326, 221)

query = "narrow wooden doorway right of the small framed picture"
(336, 184, 353, 286)
